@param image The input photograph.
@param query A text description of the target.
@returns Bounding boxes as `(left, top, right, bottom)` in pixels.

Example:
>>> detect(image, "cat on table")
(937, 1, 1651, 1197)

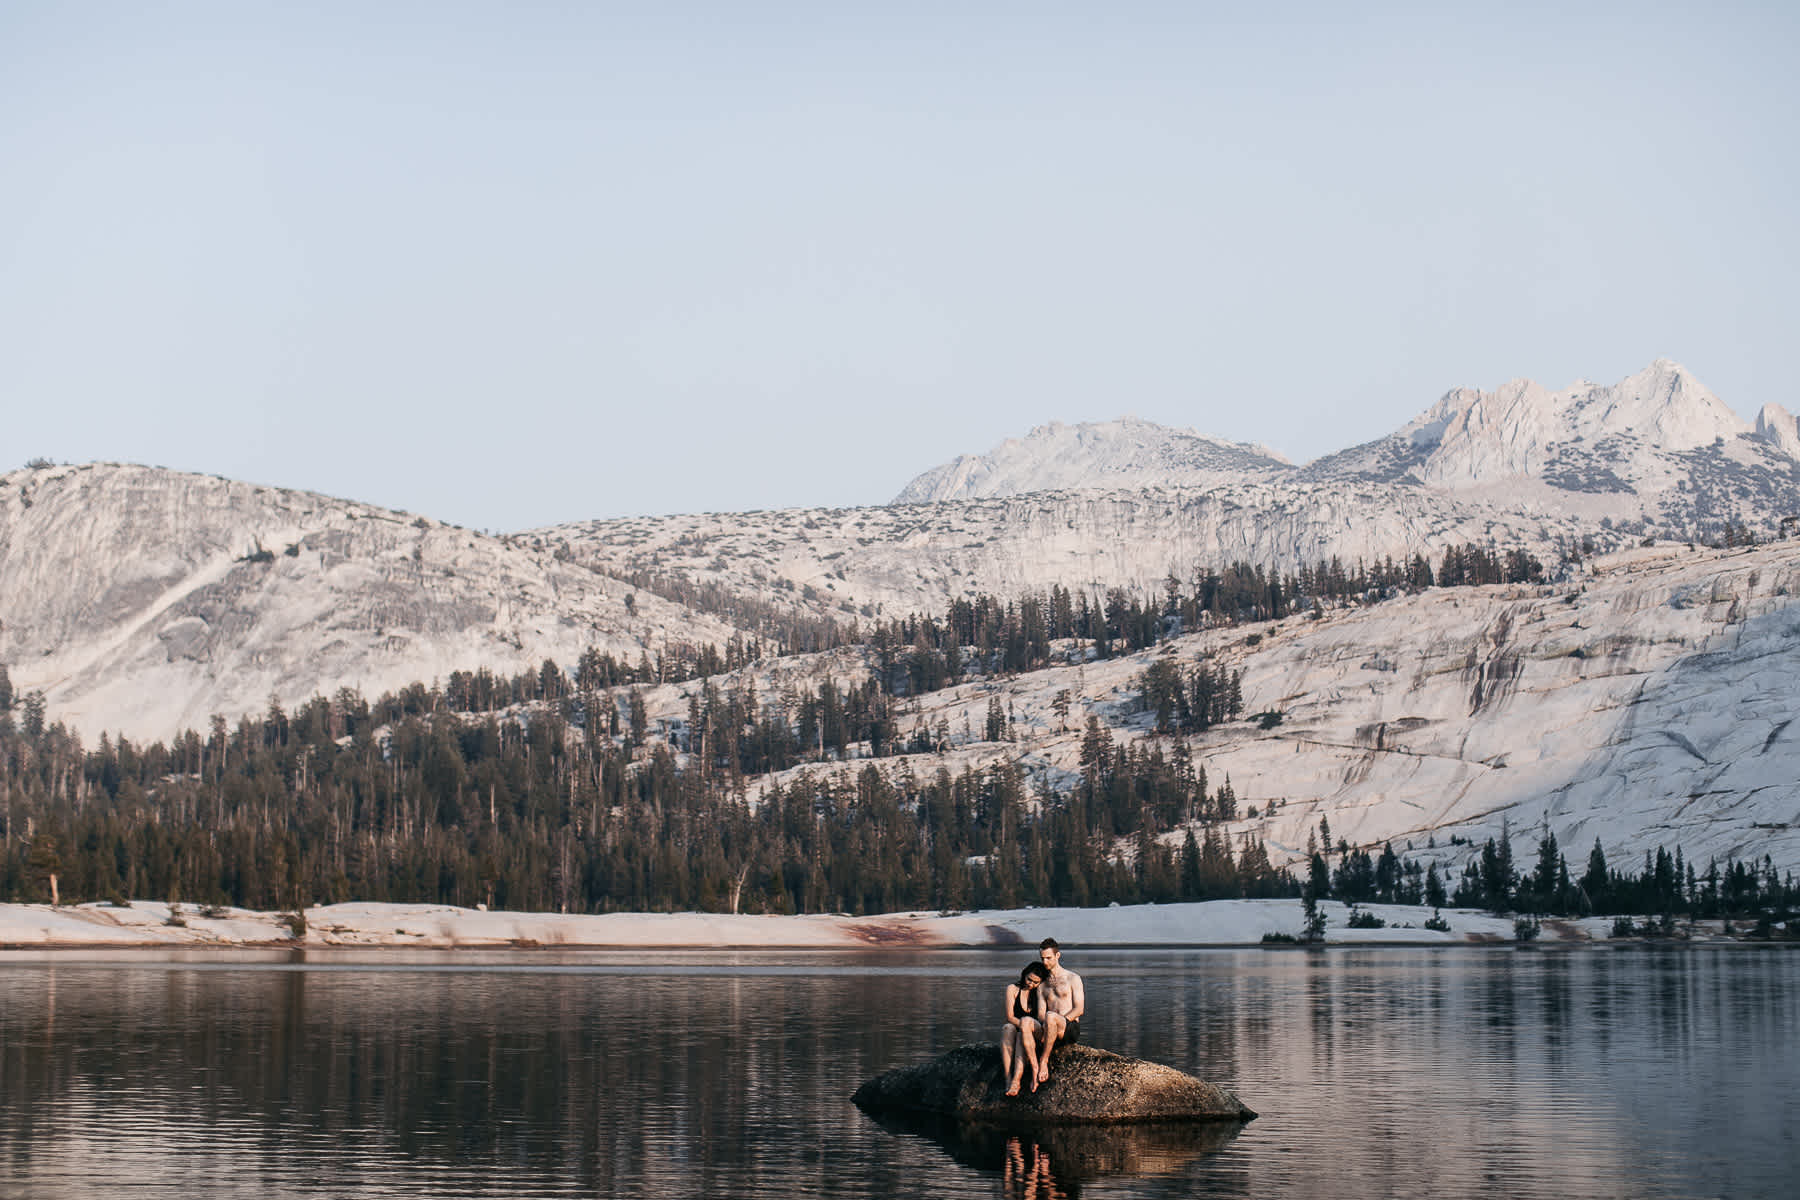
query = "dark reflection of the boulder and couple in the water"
(871, 1112, 1244, 1200)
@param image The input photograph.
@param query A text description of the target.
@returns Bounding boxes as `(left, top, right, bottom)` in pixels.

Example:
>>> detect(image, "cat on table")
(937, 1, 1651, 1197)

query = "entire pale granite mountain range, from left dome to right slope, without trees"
(0, 354, 1800, 871)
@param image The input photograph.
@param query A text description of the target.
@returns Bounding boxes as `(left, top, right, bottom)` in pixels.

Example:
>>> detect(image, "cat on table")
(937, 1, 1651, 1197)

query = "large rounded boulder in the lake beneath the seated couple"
(851, 1042, 1256, 1124)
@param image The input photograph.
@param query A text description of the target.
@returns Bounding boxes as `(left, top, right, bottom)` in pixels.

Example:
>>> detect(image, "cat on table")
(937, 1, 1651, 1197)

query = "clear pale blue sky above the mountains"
(0, 0, 1800, 531)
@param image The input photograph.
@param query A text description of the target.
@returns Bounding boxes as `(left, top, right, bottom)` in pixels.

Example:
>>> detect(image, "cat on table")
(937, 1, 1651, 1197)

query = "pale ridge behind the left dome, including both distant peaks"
(533, 360, 1800, 629)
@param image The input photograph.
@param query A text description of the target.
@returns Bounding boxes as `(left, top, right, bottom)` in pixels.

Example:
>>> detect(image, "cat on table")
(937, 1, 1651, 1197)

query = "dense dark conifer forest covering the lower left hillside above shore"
(0, 687, 1294, 914)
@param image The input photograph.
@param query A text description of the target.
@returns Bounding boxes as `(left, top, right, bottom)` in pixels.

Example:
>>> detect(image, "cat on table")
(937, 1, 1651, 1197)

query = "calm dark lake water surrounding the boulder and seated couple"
(0, 946, 1800, 1200)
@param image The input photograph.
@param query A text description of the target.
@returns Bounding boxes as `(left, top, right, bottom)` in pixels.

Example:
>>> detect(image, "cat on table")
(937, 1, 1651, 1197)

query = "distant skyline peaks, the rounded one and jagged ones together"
(895, 358, 1800, 538)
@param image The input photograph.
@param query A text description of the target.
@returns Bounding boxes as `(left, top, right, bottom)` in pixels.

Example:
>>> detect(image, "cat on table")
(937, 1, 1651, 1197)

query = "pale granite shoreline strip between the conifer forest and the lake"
(0, 900, 1735, 954)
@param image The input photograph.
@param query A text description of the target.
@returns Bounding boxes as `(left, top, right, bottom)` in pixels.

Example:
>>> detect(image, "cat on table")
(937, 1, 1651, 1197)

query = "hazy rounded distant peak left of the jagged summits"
(893, 417, 1292, 504)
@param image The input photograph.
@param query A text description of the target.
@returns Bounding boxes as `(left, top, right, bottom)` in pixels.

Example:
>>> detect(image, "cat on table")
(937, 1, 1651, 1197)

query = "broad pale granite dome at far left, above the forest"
(0, 464, 731, 738)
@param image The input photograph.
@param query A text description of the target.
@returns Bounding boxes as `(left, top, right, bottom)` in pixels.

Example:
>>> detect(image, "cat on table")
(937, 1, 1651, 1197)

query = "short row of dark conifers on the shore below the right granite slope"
(1307, 819, 1800, 919)
